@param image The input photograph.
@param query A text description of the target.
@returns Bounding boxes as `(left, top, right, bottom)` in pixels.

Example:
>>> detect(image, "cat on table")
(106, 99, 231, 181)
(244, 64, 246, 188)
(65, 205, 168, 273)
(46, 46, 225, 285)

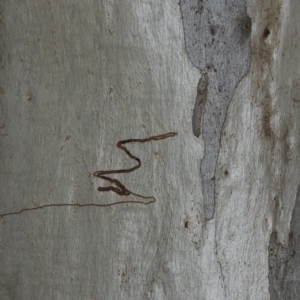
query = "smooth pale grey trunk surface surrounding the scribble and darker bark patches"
(0, 0, 300, 300)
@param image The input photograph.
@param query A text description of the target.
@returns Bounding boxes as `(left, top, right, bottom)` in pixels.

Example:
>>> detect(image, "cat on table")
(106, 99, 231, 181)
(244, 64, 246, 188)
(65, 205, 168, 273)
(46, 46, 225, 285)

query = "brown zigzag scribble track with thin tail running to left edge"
(0, 132, 177, 218)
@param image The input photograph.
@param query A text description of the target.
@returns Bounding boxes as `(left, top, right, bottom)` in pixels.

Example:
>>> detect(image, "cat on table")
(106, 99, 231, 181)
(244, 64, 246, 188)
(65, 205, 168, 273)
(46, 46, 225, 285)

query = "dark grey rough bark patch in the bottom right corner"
(269, 185, 300, 300)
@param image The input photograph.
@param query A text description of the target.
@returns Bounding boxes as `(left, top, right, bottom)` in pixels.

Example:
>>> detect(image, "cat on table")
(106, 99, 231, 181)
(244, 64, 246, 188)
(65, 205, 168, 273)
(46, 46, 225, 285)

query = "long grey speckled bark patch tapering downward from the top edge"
(180, 0, 251, 219)
